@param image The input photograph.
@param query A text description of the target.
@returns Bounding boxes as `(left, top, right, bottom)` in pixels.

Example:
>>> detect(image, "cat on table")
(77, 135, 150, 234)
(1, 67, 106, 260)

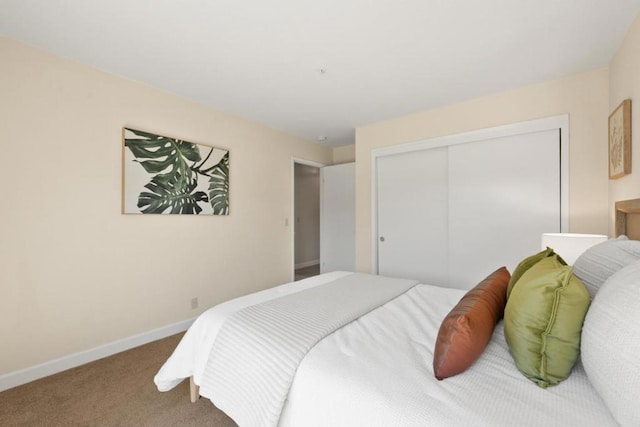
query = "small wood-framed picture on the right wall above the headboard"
(609, 99, 631, 179)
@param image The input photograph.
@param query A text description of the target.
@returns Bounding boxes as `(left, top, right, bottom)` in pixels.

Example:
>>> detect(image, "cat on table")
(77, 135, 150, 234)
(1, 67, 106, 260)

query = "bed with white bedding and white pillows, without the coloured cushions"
(154, 203, 640, 427)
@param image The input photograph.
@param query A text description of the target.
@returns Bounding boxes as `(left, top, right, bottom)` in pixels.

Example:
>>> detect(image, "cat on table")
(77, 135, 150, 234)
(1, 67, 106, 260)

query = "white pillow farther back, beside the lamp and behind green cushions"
(573, 236, 640, 298)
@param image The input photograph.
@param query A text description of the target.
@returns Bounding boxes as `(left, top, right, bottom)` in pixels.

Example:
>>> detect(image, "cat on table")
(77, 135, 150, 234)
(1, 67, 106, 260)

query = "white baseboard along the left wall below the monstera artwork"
(0, 318, 195, 391)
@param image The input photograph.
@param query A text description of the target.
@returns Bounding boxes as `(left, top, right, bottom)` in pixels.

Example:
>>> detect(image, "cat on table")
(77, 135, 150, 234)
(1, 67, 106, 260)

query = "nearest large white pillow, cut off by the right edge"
(581, 261, 640, 426)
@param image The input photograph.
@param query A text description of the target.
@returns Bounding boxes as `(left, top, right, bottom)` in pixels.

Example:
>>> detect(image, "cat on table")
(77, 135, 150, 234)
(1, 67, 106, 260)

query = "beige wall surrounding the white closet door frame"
(356, 69, 609, 272)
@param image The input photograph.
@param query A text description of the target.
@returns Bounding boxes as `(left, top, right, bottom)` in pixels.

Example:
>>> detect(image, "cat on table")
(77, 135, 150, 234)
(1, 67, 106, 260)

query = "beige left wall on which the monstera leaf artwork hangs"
(0, 38, 332, 374)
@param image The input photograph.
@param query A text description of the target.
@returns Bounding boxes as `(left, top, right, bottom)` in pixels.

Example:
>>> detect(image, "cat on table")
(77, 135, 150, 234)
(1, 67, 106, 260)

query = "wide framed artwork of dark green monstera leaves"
(122, 128, 229, 215)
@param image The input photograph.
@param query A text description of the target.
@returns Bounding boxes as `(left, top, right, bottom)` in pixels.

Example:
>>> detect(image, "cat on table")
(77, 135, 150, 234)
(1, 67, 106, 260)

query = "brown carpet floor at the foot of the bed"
(0, 334, 236, 427)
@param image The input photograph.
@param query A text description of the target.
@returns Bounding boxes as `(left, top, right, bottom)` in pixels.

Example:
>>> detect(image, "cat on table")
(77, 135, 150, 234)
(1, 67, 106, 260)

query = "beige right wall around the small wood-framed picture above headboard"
(608, 17, 640, 235)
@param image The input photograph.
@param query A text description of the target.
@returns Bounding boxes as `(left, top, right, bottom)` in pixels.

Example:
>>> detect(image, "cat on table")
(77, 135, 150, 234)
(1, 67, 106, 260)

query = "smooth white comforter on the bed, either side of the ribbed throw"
(155, 273, 616, 427)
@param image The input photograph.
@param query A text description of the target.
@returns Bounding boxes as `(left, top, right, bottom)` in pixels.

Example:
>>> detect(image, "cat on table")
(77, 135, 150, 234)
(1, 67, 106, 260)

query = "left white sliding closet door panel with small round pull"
(377, 147, 448, 285)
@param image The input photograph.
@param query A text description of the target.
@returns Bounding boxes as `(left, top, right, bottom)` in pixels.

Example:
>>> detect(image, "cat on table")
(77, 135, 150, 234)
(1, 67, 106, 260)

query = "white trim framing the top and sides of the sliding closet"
(371, 114, 569, 274)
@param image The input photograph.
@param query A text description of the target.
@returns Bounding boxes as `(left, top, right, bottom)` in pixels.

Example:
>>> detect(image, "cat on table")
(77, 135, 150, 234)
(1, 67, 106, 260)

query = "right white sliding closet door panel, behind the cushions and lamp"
(448, 129, 560, 289)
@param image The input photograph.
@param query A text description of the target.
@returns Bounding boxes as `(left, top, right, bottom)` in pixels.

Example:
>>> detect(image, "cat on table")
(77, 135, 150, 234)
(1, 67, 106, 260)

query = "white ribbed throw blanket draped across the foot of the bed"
(200, 273, 418, 427)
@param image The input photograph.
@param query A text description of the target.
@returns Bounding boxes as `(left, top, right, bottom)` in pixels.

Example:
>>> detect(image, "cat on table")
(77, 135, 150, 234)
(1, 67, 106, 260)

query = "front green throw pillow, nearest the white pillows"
(504, 255, 590, 387)
